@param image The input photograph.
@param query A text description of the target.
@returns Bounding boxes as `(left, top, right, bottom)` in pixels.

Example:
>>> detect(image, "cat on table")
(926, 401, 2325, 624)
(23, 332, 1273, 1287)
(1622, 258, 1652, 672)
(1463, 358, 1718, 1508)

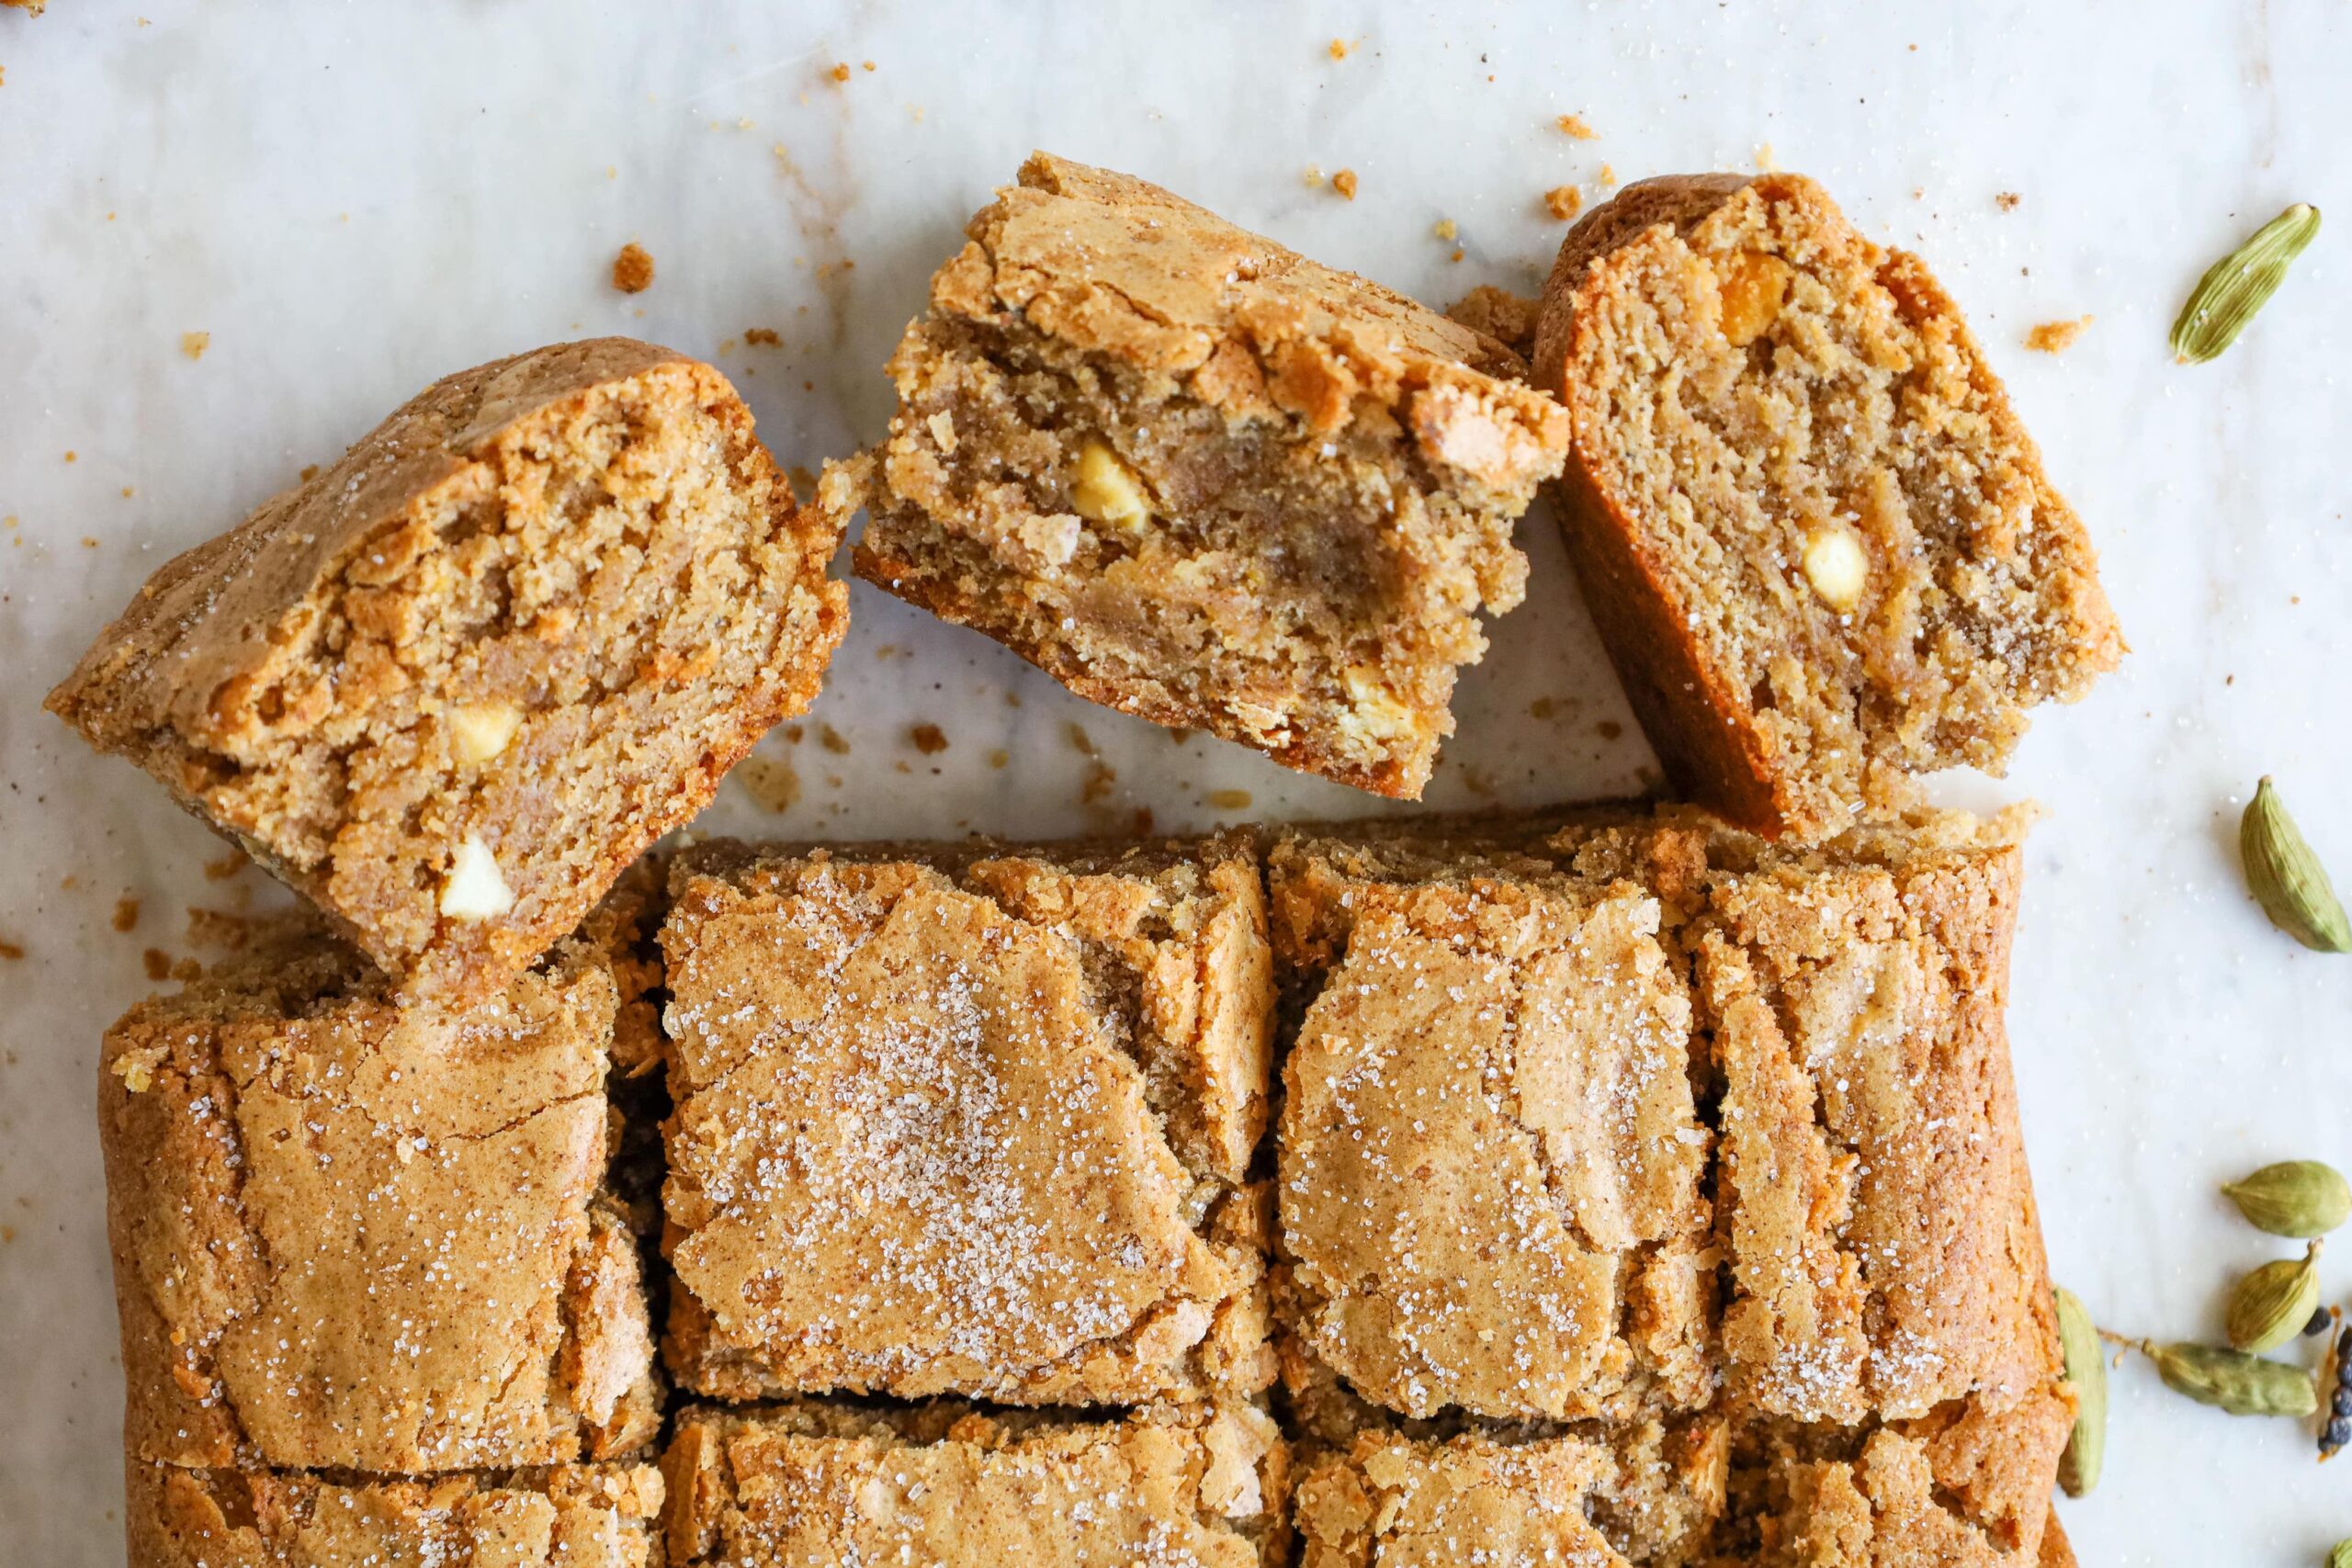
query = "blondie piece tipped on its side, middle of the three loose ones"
(820, 152, 1566, 797)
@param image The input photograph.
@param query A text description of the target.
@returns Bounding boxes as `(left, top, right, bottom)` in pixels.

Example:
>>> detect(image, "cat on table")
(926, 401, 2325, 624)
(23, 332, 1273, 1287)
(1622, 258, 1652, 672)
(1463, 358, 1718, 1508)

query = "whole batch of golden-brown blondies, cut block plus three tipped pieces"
(51, 155, 2117, 1568)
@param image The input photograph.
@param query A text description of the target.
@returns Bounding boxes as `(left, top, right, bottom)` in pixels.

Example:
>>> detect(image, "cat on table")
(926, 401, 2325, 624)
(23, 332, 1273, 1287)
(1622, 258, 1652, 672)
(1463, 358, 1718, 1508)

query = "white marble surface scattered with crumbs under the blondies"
(0, 0, 2352, 1568)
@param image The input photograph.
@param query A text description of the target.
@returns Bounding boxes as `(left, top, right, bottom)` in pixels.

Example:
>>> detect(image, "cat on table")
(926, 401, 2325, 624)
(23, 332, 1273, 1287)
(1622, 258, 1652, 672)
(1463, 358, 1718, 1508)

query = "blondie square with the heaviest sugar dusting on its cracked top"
(661, 840, 1272, 1404)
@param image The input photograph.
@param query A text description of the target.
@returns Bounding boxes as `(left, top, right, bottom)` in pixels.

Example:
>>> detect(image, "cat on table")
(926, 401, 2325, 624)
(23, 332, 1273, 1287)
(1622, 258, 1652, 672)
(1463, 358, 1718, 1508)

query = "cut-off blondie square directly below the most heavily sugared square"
(663, 1401, 1289, 1568)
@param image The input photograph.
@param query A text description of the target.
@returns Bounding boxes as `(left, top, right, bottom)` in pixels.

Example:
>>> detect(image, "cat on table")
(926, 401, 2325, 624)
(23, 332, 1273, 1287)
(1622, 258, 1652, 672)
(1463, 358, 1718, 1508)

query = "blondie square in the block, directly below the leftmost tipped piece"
(99, 900, 661, 1474)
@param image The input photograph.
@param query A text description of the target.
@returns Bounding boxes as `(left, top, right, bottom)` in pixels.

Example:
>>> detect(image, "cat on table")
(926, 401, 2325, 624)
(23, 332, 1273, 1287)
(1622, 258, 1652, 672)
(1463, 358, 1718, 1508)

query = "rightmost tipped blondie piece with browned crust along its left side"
(1536, 174, 2124, 840)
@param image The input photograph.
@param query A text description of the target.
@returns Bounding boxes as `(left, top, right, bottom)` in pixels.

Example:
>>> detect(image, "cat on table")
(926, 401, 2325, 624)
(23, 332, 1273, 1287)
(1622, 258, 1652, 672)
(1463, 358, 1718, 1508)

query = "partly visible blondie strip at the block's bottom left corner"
(127, 1462, 661, 1568)
